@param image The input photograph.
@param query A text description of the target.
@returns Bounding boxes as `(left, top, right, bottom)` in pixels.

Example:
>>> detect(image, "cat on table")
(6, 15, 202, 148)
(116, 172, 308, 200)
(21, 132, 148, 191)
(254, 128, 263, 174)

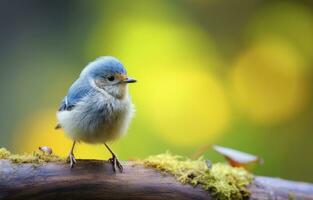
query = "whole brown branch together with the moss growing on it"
(0, 148, 313, 200)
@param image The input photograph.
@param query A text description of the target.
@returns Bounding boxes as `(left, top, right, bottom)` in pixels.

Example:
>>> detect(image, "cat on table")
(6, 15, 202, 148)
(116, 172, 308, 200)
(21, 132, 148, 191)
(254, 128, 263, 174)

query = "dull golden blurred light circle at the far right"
(230, 37, 307, 124)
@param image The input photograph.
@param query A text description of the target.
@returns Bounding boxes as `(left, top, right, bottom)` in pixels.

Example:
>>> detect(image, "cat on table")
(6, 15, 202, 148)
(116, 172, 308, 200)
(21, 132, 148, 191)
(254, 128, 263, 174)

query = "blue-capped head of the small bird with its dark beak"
(80, 56, 136, 99)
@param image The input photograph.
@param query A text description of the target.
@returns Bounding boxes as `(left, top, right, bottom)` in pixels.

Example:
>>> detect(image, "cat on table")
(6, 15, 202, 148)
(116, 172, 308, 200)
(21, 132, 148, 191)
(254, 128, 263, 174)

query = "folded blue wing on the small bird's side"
(59, 79, 92, 111)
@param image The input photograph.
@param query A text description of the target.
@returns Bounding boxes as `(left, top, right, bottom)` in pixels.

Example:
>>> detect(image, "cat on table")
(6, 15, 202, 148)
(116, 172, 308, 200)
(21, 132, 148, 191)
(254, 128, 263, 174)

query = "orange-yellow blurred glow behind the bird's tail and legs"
(12, 110, 114, 159)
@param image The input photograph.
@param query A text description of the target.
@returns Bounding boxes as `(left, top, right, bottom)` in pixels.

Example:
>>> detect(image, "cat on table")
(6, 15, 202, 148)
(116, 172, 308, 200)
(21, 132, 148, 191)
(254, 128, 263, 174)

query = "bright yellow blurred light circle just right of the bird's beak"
(137, 68, 229, 146)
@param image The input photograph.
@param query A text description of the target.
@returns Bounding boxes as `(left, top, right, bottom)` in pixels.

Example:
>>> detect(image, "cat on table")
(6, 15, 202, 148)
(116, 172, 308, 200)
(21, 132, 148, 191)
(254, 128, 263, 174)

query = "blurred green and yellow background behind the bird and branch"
(0, 0, 313, 182)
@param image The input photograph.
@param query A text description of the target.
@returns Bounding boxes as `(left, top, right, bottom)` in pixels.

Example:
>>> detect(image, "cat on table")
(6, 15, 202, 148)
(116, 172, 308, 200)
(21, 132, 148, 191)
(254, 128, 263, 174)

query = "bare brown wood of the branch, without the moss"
(0, 160, 313, 200)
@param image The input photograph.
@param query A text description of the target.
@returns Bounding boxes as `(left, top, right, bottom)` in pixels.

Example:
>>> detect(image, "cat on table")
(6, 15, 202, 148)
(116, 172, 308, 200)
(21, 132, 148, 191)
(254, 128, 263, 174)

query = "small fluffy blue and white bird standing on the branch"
(55, 56, 136, 172)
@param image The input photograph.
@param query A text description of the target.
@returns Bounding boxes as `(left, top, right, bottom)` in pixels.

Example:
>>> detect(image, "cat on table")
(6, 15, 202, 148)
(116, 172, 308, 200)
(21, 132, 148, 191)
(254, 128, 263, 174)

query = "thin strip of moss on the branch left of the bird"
(0, 148, 65, 165)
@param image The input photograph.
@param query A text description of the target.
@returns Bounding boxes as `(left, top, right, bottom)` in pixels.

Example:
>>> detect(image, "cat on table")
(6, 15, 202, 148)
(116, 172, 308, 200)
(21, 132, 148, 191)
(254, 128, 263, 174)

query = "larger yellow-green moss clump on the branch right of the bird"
(143, 152, 253, 200)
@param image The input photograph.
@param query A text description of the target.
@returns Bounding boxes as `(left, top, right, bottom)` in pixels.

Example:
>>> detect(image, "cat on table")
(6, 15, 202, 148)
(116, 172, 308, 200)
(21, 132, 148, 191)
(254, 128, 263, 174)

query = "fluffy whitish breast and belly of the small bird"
(57, 92, 134, 143)
